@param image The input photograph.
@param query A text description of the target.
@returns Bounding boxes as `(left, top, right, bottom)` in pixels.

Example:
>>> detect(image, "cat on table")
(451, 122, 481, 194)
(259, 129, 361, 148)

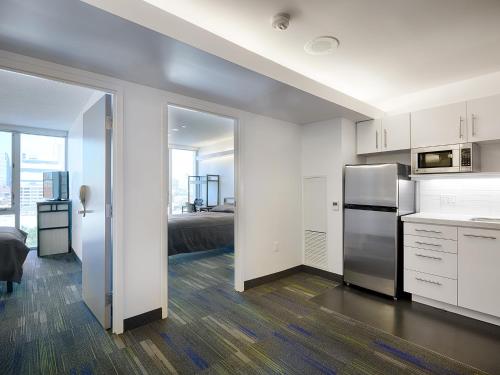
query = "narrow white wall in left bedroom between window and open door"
(67, 91, 103, 260)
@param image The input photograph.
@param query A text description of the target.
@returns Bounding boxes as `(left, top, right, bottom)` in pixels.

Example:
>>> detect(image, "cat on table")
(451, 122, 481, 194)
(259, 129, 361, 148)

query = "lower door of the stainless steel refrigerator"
(344, 208, 398, 297)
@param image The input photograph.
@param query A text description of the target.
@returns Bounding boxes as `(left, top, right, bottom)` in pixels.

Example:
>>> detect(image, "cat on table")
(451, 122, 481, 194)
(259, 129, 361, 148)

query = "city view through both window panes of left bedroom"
(0, 132, 66, 247)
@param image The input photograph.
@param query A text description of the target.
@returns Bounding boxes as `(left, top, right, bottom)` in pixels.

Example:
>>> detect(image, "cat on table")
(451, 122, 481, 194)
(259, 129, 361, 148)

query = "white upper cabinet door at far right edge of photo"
(467, 95, 500, 142)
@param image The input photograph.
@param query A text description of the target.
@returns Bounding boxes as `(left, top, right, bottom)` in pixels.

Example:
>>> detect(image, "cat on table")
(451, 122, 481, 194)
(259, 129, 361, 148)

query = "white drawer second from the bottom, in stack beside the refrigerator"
(404, 247, 457, 279)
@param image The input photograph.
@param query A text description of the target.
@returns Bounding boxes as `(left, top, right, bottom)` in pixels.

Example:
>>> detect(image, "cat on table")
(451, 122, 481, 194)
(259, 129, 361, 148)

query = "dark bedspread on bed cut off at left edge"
(0, 227, 29, 283)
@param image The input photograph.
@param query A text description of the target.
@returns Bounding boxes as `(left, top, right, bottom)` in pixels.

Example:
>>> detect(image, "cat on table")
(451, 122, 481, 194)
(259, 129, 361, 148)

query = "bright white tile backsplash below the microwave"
(417, 178, 500, 217)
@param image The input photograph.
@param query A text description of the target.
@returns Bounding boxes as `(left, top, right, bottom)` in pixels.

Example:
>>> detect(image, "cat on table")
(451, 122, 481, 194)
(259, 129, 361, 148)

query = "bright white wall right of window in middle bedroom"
(198, 138, 234, 204)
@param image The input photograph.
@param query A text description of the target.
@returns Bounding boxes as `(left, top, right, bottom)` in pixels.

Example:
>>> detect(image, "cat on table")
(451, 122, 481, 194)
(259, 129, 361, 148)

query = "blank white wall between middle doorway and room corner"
(238, 113, 302, 280)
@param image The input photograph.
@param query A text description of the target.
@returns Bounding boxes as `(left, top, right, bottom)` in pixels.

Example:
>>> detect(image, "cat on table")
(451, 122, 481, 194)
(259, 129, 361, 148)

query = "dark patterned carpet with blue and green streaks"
(0, 251, 482, 375)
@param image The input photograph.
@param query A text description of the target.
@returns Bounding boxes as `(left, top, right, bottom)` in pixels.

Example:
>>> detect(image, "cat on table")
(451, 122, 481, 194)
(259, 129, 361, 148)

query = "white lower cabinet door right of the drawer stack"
(458, 228, 500, 317)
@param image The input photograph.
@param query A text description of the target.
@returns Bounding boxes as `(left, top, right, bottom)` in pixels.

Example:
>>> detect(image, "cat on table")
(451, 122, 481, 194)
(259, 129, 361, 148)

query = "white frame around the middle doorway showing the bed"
(160, 102, 244, 319)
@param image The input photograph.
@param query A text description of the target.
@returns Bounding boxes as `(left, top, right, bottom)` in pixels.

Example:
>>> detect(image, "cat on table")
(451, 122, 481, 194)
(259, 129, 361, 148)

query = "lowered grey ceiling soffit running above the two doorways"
(0, 0, 376, 124)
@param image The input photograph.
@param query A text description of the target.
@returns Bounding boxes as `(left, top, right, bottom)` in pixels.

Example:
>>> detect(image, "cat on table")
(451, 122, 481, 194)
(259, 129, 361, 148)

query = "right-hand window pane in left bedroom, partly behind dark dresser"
(19, 134, 66, 247)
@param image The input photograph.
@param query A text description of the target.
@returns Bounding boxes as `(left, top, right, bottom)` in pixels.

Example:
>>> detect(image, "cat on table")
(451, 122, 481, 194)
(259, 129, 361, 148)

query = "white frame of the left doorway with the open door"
(0, 50, 124, 334)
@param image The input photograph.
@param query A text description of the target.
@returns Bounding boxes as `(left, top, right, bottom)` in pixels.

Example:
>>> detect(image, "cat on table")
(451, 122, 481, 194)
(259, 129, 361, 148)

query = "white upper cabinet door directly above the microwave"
(411, 102, 467, 148)
